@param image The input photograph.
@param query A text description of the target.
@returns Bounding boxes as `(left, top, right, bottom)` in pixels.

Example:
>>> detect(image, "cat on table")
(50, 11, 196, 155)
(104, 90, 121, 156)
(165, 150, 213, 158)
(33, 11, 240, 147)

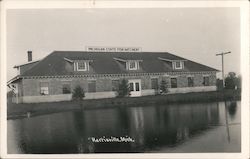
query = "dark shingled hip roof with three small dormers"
(21, 51, 218, 76)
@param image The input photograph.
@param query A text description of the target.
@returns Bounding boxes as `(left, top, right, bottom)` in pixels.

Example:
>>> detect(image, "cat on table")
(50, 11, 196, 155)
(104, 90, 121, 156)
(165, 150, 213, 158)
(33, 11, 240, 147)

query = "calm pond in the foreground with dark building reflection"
(7, 101, 241, 154)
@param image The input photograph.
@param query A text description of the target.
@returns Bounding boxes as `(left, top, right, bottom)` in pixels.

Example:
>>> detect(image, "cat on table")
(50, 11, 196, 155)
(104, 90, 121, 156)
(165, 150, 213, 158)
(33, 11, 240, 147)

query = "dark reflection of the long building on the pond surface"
(8, 102, 230, 154)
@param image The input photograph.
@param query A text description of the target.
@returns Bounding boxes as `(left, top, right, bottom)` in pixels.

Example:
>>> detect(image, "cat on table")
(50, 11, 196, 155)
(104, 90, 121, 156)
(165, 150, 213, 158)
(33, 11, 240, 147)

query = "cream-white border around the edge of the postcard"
(0, 0, 250, 159)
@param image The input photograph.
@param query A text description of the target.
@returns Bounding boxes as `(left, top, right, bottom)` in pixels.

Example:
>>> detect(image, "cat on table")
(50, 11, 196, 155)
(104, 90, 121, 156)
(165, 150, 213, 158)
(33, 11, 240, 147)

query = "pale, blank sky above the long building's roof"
(7, 8, 240, 80)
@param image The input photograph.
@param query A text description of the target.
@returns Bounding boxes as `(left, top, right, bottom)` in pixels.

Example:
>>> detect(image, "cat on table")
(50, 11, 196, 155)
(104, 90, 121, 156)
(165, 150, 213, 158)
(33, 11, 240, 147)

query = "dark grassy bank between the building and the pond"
(7, 90, 241, 119)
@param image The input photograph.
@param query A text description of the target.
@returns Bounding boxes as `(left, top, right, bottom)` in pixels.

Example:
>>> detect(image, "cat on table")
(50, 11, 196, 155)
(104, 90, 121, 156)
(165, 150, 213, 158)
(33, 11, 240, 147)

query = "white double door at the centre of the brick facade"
(128, 79, 141, 97)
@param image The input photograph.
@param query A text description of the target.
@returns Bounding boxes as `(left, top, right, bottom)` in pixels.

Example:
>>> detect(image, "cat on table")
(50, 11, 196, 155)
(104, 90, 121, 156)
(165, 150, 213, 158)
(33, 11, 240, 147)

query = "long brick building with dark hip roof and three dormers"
(7, 51, 218, 103)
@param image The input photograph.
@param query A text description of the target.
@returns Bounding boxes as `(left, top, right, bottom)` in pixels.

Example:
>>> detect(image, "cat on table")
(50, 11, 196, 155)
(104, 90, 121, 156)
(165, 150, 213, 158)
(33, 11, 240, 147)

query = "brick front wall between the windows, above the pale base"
(19, 73, 216, 96)
